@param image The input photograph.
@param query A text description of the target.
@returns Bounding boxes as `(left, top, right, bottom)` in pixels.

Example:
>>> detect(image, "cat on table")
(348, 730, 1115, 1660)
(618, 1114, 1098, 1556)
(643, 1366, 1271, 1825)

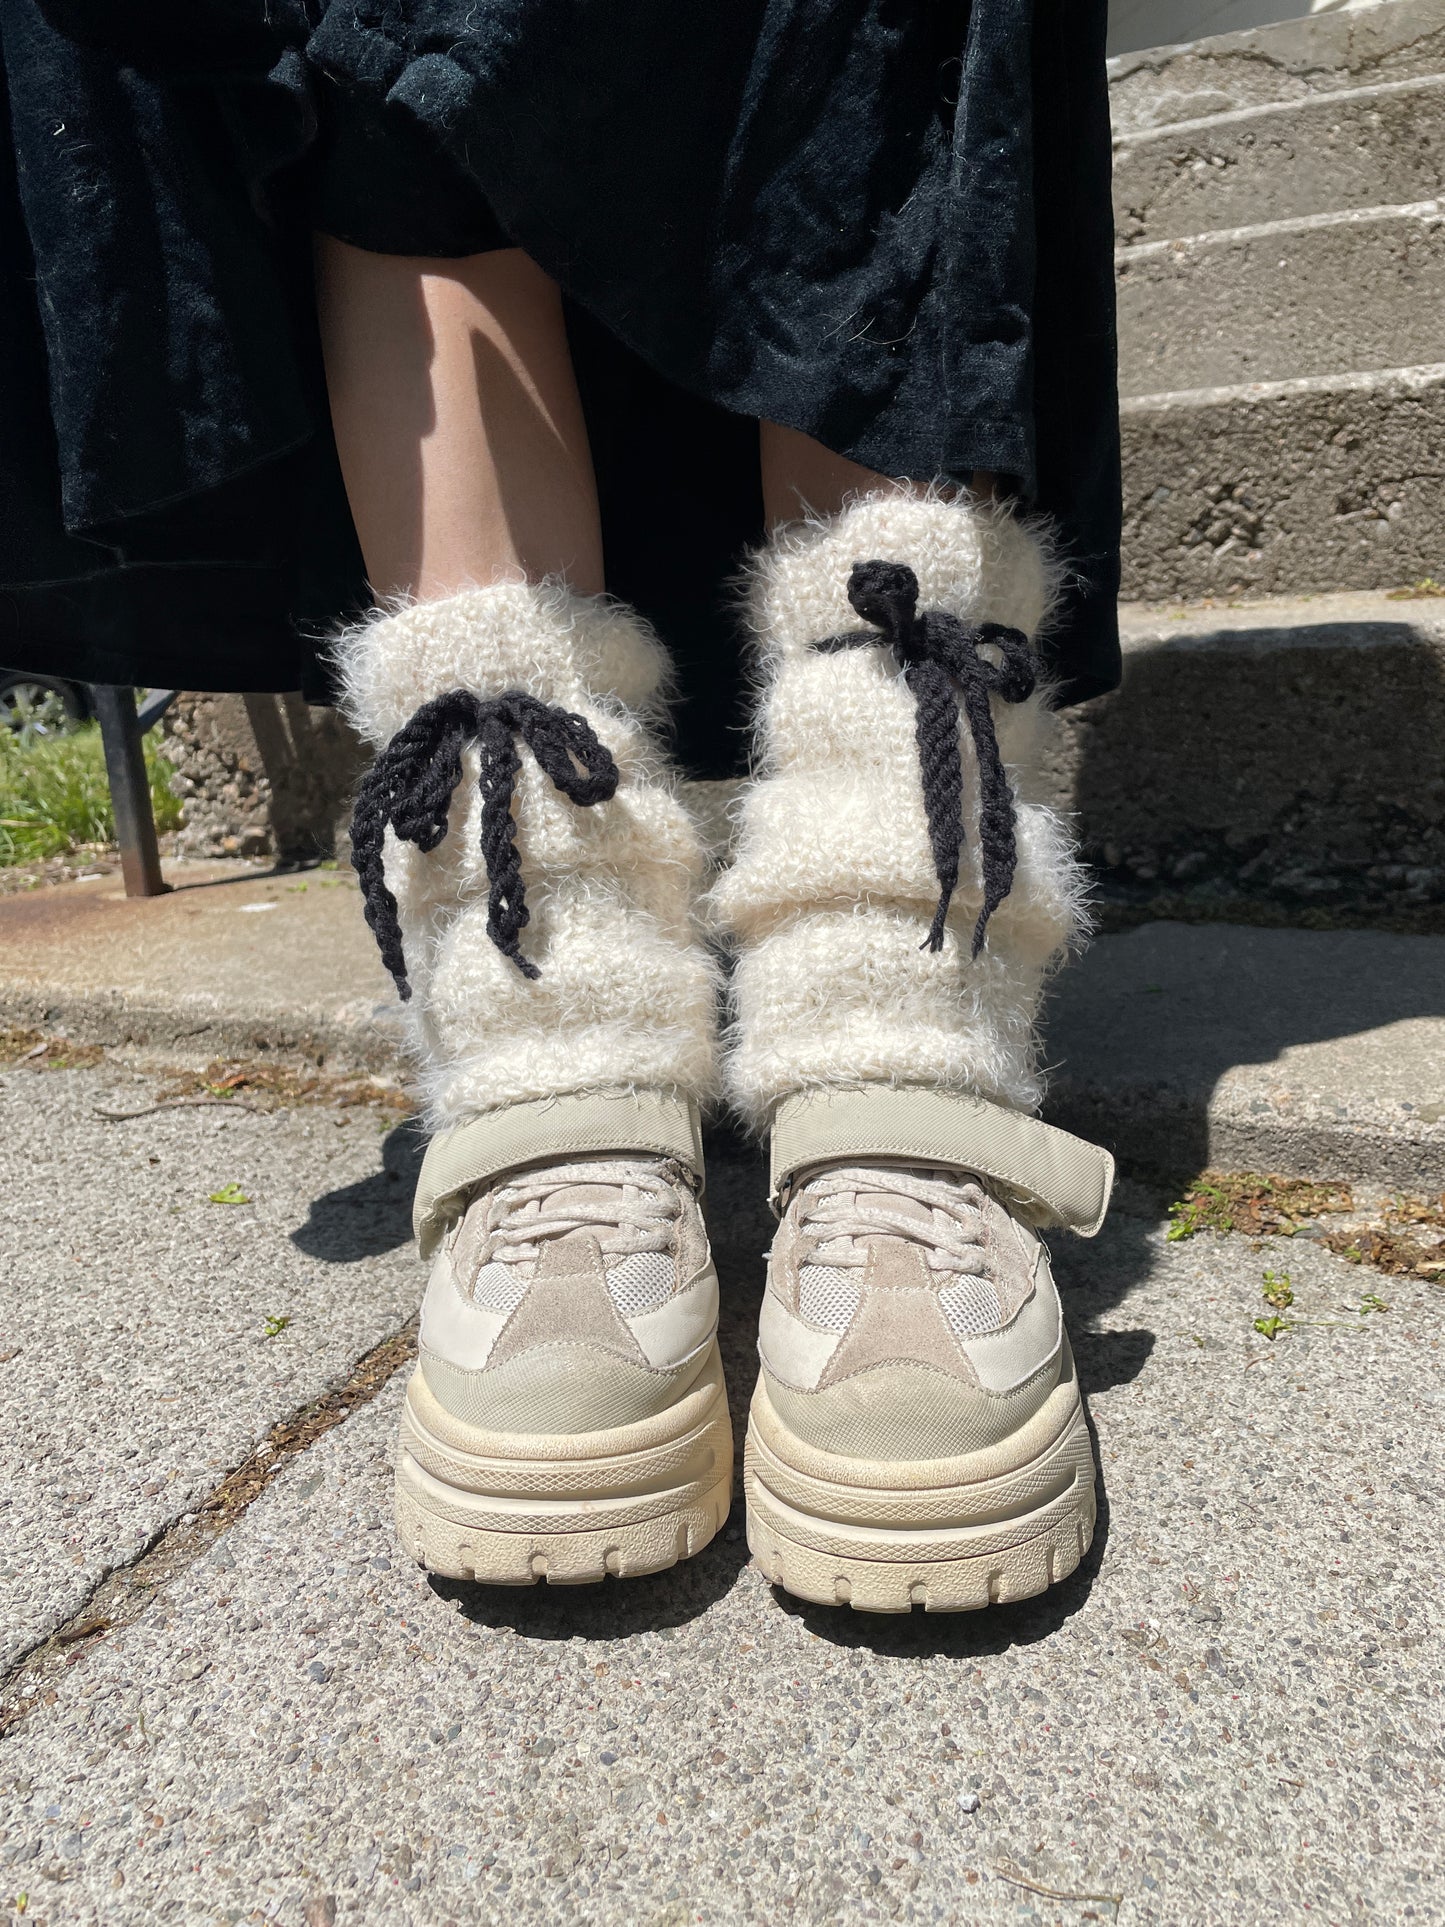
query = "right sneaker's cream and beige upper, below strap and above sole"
(757, 1164, 1067, 1459)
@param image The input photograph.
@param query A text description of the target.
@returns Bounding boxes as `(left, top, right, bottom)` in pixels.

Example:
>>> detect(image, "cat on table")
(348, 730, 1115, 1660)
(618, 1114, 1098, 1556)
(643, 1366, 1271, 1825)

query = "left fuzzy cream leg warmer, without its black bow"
(337, 582, 717, 1131)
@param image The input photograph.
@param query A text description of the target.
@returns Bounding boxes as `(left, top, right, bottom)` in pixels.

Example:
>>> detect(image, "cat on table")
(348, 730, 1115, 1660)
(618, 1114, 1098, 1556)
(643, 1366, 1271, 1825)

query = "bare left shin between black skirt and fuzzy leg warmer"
(316, 235, 603, 599)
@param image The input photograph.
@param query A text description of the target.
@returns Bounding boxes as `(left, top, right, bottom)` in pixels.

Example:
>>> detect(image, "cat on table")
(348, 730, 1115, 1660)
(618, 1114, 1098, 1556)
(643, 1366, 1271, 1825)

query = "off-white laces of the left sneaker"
(484, 1158, 678, 1262)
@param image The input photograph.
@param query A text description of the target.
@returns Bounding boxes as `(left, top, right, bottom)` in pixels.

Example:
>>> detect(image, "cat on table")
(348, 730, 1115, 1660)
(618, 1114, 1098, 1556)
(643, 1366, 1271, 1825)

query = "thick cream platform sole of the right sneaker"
(744, 1372, 1094, 1613)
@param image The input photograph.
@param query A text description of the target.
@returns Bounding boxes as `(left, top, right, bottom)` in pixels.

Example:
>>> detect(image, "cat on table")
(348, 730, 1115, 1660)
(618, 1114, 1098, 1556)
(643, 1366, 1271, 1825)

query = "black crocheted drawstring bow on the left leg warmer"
(351, 690, 618, 1002)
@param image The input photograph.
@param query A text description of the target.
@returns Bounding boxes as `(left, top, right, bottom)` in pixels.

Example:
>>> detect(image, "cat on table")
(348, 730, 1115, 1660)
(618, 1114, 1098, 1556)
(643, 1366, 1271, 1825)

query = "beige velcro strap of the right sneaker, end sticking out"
(771, 1085, 1114, 1237)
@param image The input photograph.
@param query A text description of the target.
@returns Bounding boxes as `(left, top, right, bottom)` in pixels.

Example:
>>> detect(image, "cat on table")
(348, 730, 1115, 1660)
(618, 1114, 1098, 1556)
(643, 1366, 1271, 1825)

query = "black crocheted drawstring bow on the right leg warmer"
(815, 563, 1037, 958)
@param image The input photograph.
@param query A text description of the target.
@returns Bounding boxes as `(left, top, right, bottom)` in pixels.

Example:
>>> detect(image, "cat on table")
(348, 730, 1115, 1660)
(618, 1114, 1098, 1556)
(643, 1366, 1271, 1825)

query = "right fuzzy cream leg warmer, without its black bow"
(711, 489, 1085, 1127)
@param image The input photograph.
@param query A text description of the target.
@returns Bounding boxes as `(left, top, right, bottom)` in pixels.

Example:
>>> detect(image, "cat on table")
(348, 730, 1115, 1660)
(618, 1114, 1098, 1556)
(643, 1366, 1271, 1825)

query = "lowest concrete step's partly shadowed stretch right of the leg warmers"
(1044, 923, 1445, 1193)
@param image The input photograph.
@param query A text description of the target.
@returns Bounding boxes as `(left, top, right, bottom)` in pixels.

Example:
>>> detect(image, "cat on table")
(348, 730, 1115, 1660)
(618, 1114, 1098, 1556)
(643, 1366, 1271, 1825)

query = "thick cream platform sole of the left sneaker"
(397, 1343, 732, 1586)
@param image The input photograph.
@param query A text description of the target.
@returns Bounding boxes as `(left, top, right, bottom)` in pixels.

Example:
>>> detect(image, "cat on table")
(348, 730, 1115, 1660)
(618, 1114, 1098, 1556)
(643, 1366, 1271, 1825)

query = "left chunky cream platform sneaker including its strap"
(397, 1096, 732, 1586)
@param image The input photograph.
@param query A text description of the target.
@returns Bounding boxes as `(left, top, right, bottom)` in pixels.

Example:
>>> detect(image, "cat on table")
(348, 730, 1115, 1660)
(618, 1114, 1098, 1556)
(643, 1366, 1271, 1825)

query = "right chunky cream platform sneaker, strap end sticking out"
(744, 1089, 1114, 1613)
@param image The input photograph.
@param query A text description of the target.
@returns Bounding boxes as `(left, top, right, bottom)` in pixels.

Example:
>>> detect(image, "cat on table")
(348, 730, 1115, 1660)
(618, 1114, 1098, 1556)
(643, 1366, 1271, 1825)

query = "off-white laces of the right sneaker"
(800, 1166, 988, 1278)
